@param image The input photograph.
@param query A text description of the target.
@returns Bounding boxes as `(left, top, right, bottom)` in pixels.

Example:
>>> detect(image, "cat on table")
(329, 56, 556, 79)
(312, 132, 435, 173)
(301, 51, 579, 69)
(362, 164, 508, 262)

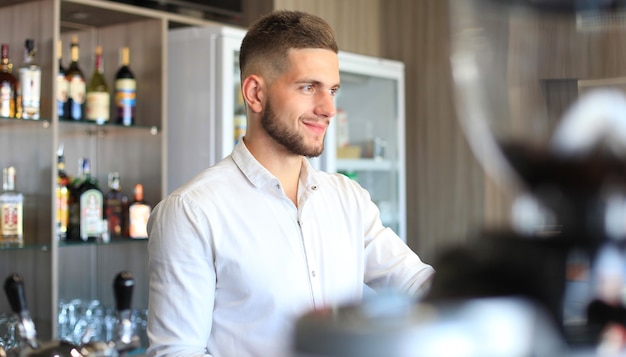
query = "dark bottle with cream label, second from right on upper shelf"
(87, 46, 111, 124)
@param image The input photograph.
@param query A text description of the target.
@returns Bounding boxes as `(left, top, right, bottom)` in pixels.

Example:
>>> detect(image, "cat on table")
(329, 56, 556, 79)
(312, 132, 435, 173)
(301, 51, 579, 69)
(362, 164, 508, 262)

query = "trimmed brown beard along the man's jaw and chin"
(261, 101, 324, 157)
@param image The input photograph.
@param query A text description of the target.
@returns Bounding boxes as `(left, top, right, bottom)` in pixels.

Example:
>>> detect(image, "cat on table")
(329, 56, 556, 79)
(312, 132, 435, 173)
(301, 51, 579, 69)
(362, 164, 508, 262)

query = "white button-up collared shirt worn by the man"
(148, 141, 434, 357)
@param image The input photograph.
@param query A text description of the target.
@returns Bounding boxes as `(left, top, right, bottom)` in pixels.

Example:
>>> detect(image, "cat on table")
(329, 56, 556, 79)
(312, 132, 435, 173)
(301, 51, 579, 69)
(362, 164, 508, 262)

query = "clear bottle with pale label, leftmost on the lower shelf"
(0, 166, 24, 245)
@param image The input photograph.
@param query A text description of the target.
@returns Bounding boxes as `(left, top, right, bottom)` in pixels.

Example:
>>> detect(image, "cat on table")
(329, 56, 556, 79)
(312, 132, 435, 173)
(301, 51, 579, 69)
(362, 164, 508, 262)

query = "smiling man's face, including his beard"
(261, 49, 339, 157)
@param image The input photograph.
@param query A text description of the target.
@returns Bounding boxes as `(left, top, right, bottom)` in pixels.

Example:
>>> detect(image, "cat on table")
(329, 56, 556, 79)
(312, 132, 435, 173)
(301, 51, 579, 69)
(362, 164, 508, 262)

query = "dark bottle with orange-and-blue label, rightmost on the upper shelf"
(115, 47, 137, 126)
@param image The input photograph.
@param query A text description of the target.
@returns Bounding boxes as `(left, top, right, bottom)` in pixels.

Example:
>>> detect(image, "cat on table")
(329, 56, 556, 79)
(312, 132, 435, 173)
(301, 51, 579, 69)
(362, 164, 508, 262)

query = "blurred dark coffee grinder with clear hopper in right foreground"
(444, 0, 626, 352)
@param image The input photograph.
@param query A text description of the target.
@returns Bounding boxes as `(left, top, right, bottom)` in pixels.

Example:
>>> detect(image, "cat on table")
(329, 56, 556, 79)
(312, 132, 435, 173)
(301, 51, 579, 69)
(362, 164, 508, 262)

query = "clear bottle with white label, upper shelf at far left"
(18, 38, 41, 119)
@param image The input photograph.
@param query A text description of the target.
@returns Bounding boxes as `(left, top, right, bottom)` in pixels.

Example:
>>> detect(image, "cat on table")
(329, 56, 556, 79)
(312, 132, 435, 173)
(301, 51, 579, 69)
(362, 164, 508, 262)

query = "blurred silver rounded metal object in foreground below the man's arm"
(295, 294, 565, 357)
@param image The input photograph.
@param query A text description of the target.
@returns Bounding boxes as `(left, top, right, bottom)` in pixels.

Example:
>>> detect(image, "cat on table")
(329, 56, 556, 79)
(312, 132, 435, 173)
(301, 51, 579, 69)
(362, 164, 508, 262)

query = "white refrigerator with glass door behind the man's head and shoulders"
(165, 25, 407, 241)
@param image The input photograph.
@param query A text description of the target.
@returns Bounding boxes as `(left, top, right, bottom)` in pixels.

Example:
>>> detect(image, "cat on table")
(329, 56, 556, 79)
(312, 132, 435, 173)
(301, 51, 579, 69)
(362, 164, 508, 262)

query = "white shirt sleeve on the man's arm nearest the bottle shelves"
(147, 196, 216, 357)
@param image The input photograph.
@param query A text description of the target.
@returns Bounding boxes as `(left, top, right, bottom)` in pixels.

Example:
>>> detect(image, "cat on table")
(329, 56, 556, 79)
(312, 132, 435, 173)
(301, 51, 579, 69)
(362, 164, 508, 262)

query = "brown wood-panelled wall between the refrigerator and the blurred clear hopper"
(380, 0, 490, 261)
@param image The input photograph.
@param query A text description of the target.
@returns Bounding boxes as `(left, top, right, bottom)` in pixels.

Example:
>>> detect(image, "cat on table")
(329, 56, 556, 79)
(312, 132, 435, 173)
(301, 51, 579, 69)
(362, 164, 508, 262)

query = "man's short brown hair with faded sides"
(239, 10, 338, 80)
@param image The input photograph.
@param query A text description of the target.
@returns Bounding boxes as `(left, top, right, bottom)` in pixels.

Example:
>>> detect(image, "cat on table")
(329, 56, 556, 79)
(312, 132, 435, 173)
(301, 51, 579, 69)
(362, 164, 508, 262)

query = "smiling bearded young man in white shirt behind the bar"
(148, 11, 434, 357)
